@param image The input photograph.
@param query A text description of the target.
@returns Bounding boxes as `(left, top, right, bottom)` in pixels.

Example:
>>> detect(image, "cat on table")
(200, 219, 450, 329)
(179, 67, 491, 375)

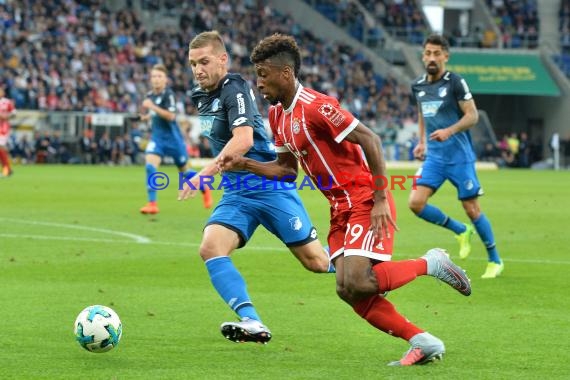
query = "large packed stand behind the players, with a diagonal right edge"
(0, 0, 415, 162)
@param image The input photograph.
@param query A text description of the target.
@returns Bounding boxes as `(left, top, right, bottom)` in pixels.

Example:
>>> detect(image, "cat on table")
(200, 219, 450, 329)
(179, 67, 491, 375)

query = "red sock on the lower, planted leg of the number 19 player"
(353, 294, 424, 341)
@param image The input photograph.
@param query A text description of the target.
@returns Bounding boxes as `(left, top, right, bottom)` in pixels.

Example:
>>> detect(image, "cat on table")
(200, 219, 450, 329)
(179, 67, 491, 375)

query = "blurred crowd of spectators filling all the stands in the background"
(0, 0, 560, 168)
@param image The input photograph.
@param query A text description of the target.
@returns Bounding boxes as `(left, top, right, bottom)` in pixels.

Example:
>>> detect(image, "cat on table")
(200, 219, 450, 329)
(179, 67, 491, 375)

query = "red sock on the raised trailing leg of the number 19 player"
(372, 259, 427, 293)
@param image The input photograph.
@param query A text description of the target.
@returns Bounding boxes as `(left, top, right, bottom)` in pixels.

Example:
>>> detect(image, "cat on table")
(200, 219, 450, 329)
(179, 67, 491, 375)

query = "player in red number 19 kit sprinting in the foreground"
(217, 34, 471, 365)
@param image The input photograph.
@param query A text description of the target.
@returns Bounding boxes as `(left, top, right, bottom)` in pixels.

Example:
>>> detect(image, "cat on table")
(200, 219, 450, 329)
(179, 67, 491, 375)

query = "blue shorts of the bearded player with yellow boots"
(416, 160, 483, 200)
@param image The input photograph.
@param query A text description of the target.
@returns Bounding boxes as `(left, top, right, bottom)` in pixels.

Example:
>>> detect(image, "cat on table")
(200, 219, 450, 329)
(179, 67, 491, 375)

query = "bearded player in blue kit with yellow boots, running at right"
(409, 35, 504, 278)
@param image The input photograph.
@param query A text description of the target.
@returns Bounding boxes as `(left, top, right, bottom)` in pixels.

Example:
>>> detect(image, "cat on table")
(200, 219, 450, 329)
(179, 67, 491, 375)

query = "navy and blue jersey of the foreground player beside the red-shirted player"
(192, 74, 277, 190)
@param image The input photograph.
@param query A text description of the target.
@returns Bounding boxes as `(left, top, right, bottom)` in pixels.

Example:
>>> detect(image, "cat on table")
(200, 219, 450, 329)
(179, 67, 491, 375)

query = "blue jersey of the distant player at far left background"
(146, 88, 184, 144)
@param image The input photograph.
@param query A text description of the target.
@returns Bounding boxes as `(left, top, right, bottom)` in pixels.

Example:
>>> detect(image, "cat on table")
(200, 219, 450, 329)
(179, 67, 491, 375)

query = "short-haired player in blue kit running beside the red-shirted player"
(178, 31, 334, 343)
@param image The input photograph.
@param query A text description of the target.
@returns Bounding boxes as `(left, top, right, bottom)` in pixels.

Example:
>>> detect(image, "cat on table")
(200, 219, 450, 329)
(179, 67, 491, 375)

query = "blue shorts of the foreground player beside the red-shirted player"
(206, 190, 317, 248)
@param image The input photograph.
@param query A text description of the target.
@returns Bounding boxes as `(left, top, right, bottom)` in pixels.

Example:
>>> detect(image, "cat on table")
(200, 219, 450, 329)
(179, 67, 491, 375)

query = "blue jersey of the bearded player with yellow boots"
(412, 71, 475, 164)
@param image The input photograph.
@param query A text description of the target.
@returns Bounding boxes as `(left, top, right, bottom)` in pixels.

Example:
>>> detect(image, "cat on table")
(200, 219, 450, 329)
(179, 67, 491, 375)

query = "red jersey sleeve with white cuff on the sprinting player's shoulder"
(311, 98, 360, 143)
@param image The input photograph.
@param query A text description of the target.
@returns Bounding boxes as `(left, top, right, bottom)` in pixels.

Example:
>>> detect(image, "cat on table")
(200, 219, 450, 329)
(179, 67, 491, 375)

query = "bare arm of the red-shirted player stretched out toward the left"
(216, 152, 299, 182)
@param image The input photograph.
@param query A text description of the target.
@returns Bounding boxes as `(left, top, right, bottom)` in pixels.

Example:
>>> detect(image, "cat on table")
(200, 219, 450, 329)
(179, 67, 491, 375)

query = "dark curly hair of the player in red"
(250, 33, 301, 77)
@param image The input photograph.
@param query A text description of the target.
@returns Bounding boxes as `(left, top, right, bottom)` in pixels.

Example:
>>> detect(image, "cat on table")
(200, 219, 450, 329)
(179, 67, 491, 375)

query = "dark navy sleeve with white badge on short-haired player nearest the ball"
(222, 81, 255, 131)
